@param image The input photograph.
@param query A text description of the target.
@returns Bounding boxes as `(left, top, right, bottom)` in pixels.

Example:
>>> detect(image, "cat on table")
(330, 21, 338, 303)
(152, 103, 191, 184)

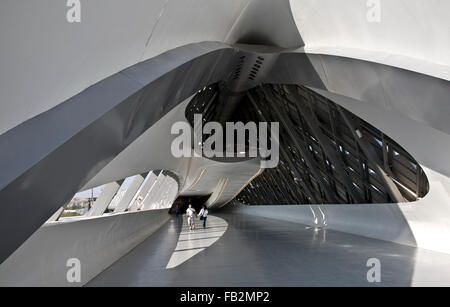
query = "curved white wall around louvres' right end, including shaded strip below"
(232, 83, 450, 253)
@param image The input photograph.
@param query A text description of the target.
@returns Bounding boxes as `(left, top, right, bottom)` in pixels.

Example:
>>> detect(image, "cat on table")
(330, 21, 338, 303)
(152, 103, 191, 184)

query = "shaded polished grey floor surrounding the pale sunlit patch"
(87, 214, 428, 287)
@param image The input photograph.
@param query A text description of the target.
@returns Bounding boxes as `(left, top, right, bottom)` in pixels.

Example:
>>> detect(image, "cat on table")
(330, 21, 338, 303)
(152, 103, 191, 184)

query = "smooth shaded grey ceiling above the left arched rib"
(0, 0, 249, 135)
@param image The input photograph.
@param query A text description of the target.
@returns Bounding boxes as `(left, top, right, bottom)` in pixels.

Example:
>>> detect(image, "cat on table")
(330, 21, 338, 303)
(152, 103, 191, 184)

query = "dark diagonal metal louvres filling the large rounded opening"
(186, 84, 428, 205)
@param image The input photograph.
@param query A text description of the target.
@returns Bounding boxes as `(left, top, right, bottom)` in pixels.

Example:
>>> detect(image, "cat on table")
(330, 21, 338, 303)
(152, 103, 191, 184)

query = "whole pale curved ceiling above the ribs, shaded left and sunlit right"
(0, 0, 450, 134)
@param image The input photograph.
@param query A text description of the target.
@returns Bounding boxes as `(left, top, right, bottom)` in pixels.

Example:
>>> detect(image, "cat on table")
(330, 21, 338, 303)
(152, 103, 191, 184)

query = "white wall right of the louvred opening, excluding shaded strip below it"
(316, 92, 450, 253)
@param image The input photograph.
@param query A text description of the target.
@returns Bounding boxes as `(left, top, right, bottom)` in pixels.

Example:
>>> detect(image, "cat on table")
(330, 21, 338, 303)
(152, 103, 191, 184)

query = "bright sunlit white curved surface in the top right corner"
(290, 0, 450, 80)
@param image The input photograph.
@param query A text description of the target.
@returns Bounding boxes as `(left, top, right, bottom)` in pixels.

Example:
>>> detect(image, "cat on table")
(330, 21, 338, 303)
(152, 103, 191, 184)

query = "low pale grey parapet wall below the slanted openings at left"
(0, 209, 170, 287)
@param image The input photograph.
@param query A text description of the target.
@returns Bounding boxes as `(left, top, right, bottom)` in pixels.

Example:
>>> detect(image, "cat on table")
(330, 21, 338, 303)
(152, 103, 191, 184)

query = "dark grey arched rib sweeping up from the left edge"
(0, 43, 234, 262)
